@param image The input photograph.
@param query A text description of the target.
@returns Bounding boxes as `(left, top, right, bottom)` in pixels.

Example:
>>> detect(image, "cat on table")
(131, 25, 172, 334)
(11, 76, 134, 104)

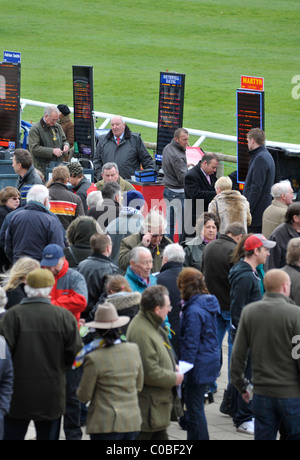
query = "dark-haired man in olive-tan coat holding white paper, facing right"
(127, 286, 183, 440)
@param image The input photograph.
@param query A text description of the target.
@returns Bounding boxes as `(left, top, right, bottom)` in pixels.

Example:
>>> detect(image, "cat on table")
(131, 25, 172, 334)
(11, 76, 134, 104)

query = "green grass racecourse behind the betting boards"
(0, 0, 300, 154)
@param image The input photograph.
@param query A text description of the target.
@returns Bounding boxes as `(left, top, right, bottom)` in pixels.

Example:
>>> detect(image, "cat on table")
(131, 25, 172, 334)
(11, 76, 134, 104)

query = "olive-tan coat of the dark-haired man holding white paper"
(127, 309, 176, 432)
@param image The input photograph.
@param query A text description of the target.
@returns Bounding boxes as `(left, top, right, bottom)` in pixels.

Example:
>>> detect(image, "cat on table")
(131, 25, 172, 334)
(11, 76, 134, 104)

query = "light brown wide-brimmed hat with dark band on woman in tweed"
(86, 302, 130, 329)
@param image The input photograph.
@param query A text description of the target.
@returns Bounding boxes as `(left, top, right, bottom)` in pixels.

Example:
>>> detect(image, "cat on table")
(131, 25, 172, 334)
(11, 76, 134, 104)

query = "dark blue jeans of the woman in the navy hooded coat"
(185, 379, 209, 441)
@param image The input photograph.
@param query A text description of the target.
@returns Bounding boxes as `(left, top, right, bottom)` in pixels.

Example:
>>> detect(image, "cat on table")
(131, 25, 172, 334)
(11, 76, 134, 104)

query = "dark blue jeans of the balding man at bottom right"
(252, 395, 300, 441)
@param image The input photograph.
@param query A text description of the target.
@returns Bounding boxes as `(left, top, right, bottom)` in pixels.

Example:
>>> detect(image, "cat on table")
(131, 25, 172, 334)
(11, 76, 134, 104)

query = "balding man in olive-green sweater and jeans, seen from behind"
(230, 269, 300, 440)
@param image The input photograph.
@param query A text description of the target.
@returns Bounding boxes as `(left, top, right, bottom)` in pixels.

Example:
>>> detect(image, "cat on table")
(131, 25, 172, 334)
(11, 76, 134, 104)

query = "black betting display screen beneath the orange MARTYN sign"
(236, 90, 264, 183)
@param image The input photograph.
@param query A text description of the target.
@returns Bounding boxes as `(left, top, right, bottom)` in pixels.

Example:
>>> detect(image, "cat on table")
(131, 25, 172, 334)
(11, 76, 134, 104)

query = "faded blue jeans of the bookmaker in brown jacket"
(163, 187, 185, 241)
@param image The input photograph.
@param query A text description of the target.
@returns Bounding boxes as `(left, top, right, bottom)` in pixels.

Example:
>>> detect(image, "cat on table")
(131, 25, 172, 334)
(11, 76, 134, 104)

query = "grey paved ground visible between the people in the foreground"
(26, 336, 254, 441)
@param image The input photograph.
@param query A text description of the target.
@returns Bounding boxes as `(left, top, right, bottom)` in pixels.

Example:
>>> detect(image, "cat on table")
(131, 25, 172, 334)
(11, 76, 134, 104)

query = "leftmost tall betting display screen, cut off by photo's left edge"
(0, 63, 21, 149)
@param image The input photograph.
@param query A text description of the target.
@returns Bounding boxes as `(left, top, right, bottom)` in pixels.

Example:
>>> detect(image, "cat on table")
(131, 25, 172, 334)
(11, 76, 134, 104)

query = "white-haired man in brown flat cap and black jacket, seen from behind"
(0, 268, 82, 440)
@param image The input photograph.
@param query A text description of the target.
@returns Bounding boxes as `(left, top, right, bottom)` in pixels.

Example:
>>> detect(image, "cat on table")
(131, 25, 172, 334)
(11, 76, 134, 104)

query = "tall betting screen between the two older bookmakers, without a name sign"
(73, 66, 95, 160)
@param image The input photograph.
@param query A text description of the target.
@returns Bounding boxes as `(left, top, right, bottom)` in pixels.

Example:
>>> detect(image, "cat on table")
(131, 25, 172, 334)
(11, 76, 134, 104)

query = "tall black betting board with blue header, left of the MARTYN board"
(155, 72, 185, 164)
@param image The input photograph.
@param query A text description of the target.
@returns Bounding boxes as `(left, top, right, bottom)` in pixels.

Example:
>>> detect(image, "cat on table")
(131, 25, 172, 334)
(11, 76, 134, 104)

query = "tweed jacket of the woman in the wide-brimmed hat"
(77, 342, 143, 433)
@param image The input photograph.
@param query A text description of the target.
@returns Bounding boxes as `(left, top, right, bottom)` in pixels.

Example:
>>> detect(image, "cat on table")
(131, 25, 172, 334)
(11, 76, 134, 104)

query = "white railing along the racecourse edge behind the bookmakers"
(21, 98, 300, 152)
